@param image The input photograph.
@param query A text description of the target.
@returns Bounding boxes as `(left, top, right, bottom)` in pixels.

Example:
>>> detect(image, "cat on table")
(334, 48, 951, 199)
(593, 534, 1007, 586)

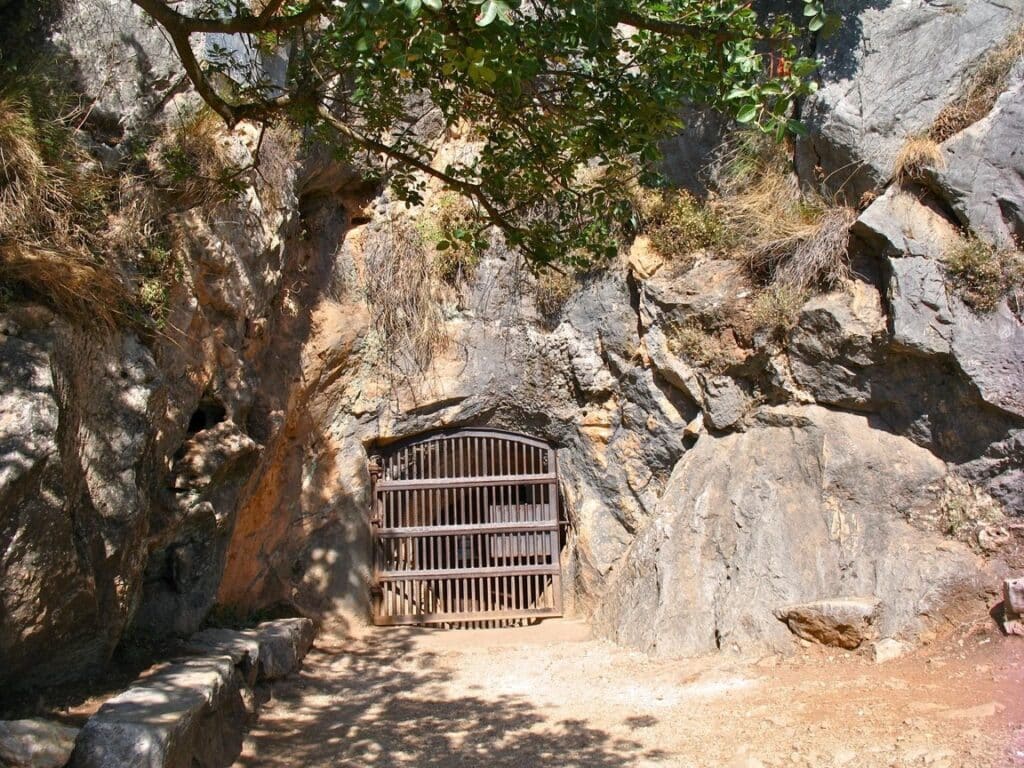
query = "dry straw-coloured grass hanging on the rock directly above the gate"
(366, 210, 450, 370)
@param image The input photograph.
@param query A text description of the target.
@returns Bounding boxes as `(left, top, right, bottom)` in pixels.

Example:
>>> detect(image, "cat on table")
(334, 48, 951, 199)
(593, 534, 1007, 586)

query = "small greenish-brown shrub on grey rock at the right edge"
(945, 236, 1024, 312)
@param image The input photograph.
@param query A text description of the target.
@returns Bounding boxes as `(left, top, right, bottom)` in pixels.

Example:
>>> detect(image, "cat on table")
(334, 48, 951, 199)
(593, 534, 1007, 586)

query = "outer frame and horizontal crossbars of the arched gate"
(369, 427, 563, 626)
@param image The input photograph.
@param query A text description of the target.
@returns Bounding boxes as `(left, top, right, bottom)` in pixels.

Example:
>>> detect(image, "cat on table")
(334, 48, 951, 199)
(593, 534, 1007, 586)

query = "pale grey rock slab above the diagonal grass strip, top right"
(797, 0, 1024, 202)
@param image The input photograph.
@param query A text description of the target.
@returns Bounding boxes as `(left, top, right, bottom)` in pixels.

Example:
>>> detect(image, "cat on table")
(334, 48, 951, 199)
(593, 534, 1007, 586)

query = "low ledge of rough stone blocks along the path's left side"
(0, 618, 314, 768)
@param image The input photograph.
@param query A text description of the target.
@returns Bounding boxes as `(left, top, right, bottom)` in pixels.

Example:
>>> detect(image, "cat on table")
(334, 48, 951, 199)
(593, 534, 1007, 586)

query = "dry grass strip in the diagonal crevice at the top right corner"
(928, 27, 1024, 143)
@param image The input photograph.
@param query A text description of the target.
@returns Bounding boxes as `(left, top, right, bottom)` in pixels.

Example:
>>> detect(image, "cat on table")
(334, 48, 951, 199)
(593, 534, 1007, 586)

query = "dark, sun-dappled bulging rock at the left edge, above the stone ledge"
(0, 325, 160, 686)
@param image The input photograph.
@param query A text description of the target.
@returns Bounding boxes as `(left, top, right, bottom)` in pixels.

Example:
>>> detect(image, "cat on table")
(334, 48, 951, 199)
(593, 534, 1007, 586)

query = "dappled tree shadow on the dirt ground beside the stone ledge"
(236, 630, 666, 768)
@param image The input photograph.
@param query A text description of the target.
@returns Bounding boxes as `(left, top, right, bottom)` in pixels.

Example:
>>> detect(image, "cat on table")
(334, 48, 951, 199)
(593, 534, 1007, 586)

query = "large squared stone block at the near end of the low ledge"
(70, 656, 246, 768)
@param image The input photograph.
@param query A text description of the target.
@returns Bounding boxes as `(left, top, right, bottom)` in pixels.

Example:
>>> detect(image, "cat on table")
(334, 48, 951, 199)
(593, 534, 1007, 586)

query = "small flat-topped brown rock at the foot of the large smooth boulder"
(775, 597, 879, 650)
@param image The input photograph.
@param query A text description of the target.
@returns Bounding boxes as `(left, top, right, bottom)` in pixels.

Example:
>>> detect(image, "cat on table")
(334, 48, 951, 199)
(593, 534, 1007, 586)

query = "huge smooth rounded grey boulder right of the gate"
(594, 406, 990, 655)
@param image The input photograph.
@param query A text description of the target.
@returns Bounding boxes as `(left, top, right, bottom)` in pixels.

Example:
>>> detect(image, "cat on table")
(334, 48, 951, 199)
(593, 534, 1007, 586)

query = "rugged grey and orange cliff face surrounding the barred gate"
(0, 0, 1024, 696)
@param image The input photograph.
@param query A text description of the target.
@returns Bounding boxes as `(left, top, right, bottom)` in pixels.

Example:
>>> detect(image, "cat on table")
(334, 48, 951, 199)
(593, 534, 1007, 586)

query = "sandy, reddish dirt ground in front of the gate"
(236, 620, 1024, 768)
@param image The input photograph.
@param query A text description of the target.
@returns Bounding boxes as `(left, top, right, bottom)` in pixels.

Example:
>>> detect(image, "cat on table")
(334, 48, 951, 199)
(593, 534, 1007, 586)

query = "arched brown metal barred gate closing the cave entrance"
(371, 429, 562, 625)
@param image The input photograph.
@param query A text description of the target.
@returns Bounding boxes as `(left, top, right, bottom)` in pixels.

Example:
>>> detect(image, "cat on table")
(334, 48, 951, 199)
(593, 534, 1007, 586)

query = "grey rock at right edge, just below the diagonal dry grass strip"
(936, 67, 1024, 248)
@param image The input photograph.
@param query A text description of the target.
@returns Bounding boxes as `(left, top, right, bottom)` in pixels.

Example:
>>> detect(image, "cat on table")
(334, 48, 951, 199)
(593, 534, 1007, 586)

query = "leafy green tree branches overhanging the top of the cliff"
(132, 0, 826, 264)
